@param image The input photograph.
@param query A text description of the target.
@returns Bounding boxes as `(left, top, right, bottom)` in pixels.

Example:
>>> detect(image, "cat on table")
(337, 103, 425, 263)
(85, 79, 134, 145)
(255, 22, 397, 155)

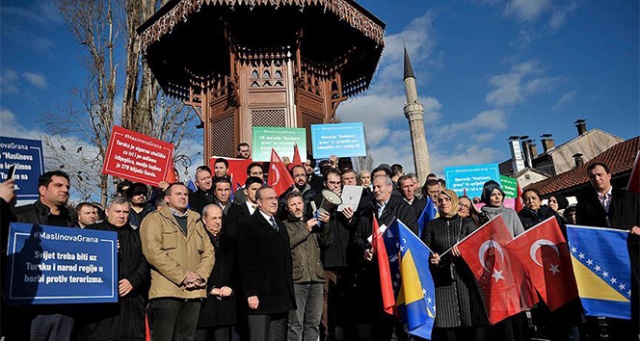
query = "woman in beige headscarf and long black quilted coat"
(422, 189, 487, 341)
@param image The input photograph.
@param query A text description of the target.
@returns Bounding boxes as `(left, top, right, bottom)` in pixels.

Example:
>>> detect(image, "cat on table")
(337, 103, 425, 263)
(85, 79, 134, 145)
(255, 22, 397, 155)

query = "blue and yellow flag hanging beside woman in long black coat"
(383, 219, 436, 339)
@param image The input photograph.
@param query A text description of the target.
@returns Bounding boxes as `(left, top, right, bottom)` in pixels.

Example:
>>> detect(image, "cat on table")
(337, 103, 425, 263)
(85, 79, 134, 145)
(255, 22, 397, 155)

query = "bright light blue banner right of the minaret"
(444, 163, 500, 198)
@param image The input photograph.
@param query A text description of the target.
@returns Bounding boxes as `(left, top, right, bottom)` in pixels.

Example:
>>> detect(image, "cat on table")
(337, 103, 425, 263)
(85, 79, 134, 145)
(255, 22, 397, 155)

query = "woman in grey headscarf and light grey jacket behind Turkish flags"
(480, 180, 527, 341)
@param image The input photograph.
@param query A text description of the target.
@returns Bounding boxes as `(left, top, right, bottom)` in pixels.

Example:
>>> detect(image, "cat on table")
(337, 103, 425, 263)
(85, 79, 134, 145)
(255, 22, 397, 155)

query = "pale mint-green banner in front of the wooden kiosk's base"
(251, 127, 307, 162)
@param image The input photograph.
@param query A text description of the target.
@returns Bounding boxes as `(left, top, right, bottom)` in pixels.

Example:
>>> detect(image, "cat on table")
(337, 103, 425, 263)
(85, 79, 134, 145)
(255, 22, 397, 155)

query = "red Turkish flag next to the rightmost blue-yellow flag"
(506, 217, 578, 311)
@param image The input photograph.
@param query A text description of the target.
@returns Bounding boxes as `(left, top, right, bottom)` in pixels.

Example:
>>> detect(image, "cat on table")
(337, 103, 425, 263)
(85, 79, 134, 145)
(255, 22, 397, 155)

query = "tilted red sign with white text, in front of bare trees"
(102, 126, 173, 186)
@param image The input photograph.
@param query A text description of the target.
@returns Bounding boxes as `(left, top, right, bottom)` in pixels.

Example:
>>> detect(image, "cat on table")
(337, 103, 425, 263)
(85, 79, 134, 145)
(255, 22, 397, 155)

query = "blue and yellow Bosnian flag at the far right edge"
(567, 225, 631, 320)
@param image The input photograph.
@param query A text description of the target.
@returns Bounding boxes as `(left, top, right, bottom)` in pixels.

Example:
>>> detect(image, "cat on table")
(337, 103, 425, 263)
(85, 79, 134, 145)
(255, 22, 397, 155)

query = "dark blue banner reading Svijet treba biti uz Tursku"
(5, 223, 118, 304)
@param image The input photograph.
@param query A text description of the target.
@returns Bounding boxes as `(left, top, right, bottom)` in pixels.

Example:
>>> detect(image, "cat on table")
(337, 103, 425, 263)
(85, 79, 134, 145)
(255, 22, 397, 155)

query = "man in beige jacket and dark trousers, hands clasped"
(140, 183, 214, 341)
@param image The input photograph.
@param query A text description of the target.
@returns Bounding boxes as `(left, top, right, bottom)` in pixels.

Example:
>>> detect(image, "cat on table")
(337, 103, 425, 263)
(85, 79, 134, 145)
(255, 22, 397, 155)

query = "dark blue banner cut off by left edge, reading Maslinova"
(0, 136, 44, 200)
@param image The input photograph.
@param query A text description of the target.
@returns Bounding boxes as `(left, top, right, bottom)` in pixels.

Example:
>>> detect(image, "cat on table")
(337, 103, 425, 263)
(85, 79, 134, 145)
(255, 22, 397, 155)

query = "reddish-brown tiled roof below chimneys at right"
(525, 136, 640, 196)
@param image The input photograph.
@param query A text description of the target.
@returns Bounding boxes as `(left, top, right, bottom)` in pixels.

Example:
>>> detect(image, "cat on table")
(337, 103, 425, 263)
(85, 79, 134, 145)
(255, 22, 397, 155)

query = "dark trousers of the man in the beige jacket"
(149, 298, 202, 341)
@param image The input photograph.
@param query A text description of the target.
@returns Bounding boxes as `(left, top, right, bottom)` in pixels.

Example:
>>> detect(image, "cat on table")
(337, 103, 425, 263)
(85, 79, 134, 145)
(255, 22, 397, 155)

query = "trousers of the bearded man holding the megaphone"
(287, 282, 324, 341)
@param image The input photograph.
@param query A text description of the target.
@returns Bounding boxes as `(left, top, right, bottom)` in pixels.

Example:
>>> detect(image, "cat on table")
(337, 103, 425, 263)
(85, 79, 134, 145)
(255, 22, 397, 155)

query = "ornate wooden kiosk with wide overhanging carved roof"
(138, 0, 385, 157)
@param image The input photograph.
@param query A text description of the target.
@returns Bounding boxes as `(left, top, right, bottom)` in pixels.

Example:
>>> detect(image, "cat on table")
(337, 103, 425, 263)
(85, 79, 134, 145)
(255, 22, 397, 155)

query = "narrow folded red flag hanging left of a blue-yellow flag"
(371, 215, 396, 315)
